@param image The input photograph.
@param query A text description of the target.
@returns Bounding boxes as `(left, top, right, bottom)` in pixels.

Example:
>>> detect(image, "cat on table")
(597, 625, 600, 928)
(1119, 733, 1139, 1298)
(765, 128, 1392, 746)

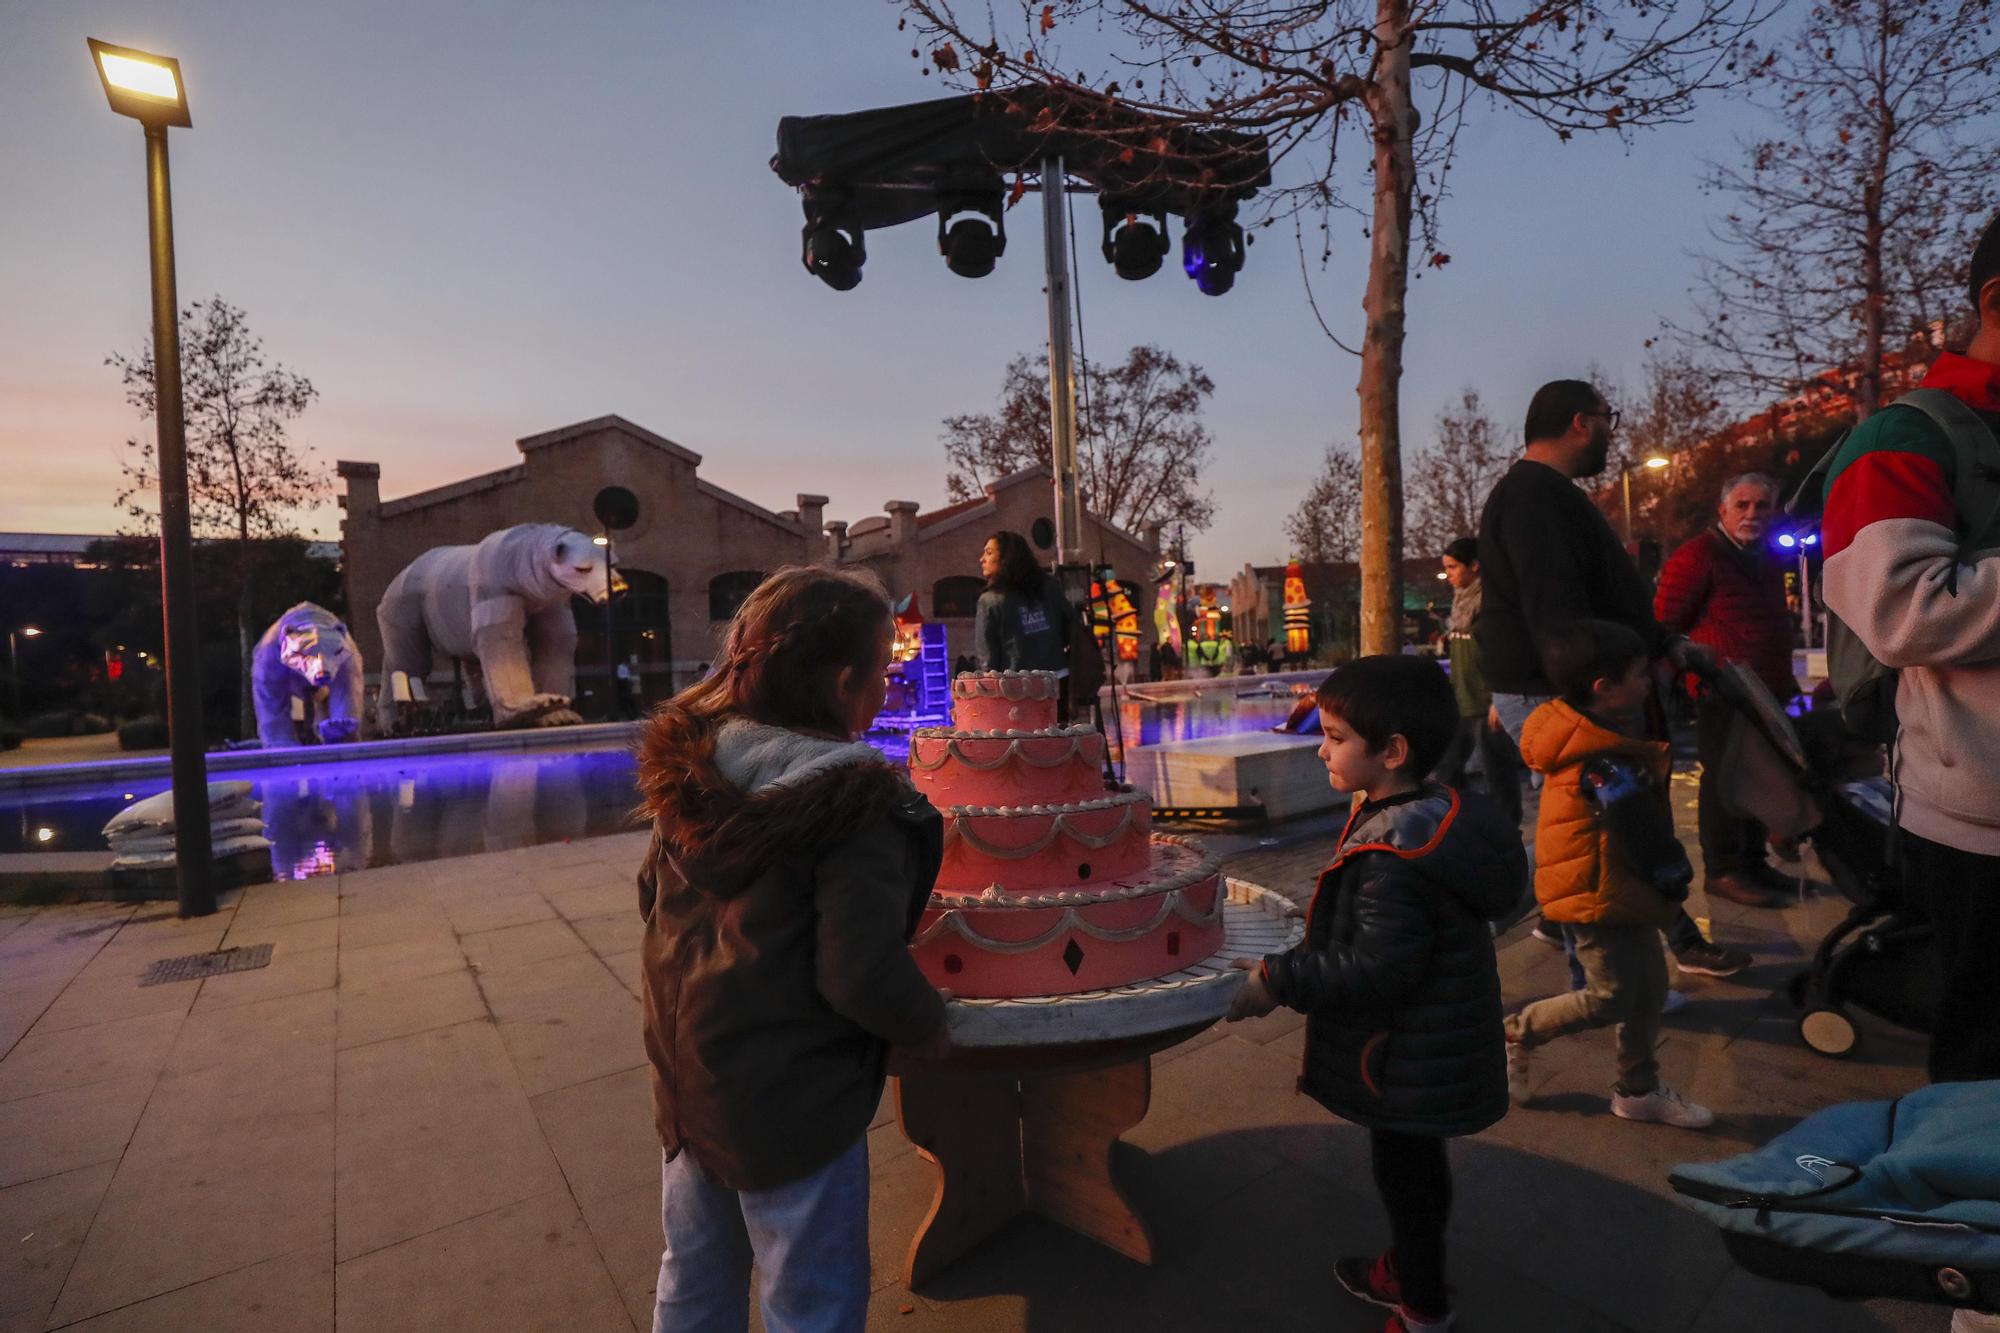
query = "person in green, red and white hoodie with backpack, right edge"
(1824, 218, 2000, 1083)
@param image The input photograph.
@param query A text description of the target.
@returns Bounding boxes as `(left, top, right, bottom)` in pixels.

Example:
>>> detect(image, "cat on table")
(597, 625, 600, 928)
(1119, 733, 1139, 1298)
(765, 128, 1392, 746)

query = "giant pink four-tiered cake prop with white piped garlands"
(910, 671, 1226, 999)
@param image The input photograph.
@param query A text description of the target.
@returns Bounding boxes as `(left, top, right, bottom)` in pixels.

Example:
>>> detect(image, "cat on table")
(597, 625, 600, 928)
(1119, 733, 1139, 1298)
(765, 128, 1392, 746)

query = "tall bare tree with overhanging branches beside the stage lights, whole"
(896, 0, 1776, 652)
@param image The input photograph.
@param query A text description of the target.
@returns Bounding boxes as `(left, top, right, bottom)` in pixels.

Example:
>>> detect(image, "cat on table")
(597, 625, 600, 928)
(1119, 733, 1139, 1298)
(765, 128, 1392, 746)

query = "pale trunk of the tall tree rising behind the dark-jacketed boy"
(1358, 0, 1416, 654)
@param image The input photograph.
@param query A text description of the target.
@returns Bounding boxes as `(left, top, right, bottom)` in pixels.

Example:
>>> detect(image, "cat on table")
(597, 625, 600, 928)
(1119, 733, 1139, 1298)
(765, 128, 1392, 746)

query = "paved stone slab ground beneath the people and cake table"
(0, 768, 1944, 1333)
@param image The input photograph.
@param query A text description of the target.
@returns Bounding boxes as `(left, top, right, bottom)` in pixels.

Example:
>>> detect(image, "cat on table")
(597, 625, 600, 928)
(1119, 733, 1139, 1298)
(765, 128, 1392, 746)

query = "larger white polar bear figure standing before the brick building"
(376, 522, 610, 733)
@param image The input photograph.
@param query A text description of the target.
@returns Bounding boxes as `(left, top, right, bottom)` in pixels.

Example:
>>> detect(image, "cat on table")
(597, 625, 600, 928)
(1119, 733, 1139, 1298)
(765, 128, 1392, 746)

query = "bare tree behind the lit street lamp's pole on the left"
(104, 296, 332, 735)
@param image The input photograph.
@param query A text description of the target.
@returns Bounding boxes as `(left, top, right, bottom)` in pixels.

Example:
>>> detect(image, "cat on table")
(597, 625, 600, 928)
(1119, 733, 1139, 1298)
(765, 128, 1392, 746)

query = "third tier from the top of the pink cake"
(936, 791, 1152, 893)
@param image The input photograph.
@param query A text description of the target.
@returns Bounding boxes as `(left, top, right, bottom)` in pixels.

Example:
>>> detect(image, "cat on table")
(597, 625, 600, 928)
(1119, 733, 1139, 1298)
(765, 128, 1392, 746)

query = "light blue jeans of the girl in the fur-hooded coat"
(652, 1137, 868, 1333)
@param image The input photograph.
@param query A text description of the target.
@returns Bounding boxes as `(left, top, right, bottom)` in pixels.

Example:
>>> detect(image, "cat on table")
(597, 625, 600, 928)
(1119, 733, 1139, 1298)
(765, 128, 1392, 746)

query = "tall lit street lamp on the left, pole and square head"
(88, 38, 216, 917)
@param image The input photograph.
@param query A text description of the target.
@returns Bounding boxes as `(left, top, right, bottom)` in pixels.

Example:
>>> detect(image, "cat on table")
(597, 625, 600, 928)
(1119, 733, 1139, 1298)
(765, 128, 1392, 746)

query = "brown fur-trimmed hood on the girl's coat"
(638, 719, 922, 897)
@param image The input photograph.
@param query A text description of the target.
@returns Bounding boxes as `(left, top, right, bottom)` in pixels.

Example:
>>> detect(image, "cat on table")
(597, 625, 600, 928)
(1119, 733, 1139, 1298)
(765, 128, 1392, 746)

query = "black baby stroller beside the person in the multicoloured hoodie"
(1708, 664, 1938, 1059)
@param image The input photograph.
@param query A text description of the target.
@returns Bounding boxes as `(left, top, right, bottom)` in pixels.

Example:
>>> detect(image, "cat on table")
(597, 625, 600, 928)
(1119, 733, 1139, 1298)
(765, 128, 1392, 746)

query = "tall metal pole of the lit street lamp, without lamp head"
(146, 124, 216, 917)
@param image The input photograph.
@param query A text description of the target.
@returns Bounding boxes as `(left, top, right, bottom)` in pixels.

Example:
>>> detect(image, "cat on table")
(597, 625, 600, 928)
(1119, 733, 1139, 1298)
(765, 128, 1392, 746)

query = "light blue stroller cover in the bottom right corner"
(1668, 1081, 2000, 1303)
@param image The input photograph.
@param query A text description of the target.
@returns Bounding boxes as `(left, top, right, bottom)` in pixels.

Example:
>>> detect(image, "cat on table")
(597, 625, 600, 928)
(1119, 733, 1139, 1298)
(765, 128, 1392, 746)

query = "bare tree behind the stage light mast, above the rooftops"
(944, 346, 1216, 532)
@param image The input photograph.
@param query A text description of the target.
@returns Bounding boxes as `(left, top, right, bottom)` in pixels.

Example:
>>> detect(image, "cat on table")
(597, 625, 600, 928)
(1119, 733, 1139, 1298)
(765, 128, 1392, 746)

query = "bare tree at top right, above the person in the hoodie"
(1674, 0, 2000, 416)
